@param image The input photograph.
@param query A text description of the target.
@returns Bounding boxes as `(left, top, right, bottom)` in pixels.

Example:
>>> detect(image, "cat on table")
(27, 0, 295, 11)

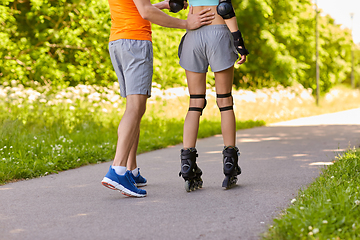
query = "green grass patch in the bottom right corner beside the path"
(263, 149, 360, 240)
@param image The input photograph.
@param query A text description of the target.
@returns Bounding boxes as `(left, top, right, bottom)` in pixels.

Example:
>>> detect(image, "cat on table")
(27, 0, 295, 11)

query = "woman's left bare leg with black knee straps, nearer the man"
(183, 71, 206, 149)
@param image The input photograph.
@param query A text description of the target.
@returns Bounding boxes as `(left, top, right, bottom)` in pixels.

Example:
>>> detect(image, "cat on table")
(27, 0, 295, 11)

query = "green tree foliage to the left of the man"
(0, 0, 115, 86)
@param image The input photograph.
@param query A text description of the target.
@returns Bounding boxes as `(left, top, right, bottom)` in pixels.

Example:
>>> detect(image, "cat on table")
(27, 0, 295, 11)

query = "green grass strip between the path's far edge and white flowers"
(0, 104, 265, 184)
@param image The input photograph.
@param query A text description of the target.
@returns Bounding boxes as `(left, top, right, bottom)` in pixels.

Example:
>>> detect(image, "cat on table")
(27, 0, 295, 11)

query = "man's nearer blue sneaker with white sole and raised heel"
(101, 166, 146, 197)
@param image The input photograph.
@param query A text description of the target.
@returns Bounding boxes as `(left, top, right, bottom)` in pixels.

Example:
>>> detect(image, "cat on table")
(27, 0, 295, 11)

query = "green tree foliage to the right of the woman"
(235, 0, 360, 93)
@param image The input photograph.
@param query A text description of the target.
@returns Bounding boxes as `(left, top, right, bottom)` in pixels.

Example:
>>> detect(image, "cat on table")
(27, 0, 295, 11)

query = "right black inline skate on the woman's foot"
(222, 147, 241, 189)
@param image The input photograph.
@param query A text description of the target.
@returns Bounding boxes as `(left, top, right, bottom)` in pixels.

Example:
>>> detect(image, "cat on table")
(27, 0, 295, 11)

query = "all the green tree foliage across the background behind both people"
(0, 0, 360, 93)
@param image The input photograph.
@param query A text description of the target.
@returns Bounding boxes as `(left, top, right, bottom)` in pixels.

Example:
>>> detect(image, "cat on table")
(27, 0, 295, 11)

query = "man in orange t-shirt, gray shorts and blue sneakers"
(102, 0, 214, 197)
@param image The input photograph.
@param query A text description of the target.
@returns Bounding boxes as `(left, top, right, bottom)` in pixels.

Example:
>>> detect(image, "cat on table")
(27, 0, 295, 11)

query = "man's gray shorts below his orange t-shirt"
(109, 39, 153, 97)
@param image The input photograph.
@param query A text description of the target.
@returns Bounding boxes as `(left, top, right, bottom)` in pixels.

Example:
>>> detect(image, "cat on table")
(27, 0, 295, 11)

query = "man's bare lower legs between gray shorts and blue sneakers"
(113, 94, 148, 167)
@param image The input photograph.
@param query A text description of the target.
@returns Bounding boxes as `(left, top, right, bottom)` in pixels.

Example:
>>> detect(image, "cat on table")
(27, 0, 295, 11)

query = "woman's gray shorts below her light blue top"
(178, 25, 239, 73)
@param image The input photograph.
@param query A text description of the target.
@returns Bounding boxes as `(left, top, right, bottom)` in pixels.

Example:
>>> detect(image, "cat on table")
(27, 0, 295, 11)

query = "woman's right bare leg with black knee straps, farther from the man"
(214, 66, 236, 147)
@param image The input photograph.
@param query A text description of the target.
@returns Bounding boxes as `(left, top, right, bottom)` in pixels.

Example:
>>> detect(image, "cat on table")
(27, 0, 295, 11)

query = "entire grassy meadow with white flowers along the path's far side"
(0, 81, 360, 185)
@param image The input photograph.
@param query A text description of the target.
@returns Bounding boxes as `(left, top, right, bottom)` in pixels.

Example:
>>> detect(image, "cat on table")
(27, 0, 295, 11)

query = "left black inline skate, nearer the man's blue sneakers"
(179, 148, 203, 192)
